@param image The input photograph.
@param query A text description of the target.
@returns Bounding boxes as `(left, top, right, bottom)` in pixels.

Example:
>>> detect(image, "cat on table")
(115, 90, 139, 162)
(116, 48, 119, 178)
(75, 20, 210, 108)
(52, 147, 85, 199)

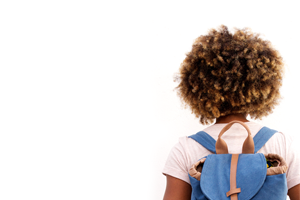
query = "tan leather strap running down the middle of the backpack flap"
(226, 154, 241, 200)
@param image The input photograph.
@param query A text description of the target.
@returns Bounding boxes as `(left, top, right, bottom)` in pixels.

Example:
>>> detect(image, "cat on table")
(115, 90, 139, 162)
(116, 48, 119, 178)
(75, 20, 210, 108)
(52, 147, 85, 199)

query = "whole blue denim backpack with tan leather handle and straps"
(189, 121, 287, 200)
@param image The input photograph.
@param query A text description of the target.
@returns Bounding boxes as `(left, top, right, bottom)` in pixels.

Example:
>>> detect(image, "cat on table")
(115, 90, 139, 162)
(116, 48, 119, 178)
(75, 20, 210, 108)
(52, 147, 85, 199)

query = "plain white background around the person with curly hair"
(0, 0, 300, 200)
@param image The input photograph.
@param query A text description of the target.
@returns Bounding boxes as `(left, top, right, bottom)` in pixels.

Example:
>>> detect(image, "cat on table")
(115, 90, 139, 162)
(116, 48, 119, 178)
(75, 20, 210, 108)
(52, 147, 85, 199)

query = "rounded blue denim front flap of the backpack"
(200, 153, 267, 200)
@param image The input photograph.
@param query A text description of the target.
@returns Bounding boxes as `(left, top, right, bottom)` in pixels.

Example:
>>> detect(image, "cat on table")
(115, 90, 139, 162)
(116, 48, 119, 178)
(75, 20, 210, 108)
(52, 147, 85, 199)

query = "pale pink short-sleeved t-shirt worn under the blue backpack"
(162, 122, 300, 189)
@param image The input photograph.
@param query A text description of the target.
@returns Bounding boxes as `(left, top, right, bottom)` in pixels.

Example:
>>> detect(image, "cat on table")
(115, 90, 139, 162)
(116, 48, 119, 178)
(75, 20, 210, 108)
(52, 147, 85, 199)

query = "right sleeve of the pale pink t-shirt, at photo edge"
(286, 135, 300, 189)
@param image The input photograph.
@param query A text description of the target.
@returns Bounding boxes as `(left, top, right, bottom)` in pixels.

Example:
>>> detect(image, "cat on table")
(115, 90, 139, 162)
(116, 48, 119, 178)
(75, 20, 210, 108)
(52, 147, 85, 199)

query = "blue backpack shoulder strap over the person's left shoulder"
(189, 131, 216, 153)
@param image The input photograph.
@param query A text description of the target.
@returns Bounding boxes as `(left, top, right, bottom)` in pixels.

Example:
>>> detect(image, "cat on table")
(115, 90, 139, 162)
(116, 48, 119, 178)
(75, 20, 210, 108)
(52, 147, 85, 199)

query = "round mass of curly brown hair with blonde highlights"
(174, 25, 283, 124)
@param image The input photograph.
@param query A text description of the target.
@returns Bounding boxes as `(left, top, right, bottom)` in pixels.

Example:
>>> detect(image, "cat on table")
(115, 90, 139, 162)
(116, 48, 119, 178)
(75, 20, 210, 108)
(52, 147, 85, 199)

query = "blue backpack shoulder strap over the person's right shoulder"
(253, 127, 278, 153)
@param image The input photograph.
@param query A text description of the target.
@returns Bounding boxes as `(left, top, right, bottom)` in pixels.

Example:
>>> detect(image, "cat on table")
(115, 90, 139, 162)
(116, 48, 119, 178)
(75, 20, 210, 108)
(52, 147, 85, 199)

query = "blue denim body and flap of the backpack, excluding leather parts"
(189, 153, 287, 200)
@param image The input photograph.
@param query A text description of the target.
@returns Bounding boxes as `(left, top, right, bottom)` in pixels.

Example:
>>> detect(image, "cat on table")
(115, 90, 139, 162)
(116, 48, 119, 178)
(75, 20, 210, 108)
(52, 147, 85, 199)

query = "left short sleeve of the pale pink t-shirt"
(162, 139, 190, 184)
